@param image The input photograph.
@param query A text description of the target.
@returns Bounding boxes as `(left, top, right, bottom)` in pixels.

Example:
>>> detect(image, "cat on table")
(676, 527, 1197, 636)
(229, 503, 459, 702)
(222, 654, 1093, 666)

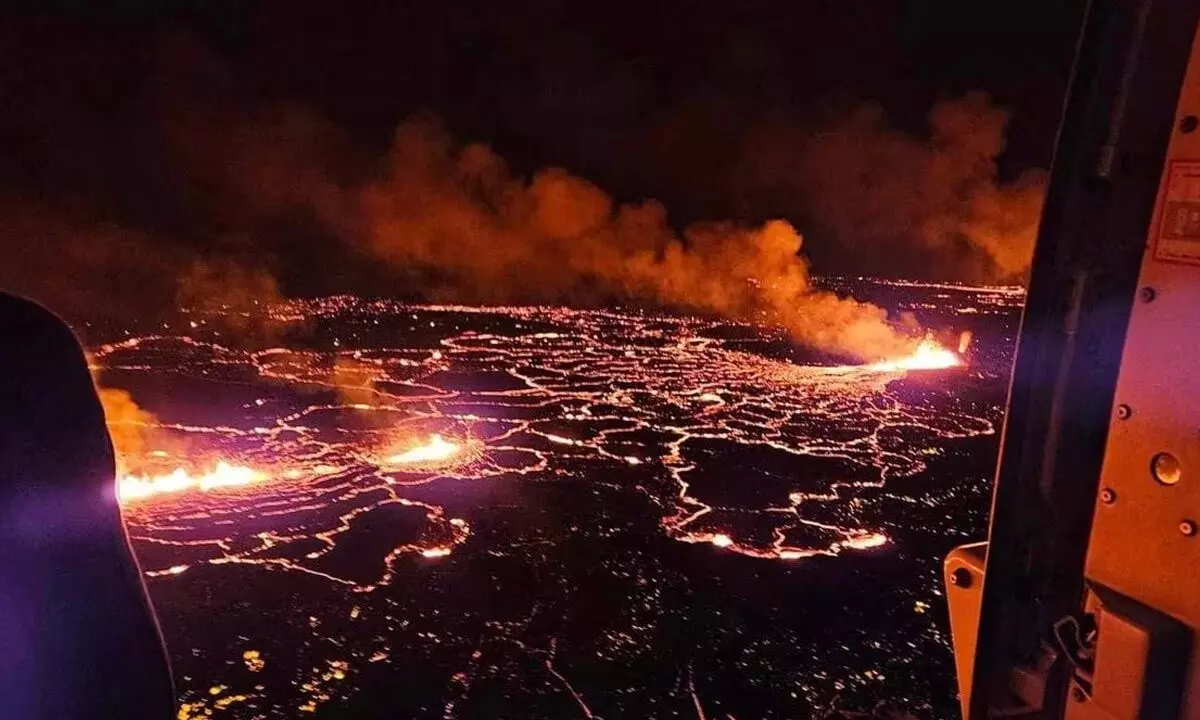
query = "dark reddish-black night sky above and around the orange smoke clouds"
(0, 0, 1081, 324)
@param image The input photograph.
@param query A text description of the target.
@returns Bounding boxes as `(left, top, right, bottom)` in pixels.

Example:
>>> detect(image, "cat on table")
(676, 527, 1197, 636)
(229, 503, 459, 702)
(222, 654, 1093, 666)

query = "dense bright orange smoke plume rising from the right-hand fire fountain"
(342, 119, 919, 359)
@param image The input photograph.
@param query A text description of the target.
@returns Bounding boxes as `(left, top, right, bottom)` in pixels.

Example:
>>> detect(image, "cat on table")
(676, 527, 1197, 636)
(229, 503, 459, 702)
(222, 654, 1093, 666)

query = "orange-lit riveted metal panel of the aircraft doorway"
(1084, 18, 1200, 716)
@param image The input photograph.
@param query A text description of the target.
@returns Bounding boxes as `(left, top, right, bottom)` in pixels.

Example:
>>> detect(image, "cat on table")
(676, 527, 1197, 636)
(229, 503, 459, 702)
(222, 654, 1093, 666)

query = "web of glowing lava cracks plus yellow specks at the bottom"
(94, 288, 1012, 716)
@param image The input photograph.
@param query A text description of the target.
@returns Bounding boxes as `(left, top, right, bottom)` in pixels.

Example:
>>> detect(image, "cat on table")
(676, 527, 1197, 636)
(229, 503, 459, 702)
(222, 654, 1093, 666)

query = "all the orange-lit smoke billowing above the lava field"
(0, 35, 1042, 360)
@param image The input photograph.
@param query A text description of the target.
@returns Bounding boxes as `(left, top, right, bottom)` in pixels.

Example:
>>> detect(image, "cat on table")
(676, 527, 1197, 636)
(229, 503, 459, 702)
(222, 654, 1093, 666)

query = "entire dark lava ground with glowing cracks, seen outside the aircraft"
(94, 278, 1021, 720)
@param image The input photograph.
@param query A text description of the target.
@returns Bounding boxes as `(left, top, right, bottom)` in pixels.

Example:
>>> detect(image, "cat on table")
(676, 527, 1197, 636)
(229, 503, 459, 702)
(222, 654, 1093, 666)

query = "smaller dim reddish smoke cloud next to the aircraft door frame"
(740, 92, 1046, 282)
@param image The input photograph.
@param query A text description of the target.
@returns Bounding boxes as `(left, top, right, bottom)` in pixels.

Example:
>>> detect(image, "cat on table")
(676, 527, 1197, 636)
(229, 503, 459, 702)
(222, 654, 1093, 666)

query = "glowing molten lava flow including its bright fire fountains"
(95, 295, 998, 593)
